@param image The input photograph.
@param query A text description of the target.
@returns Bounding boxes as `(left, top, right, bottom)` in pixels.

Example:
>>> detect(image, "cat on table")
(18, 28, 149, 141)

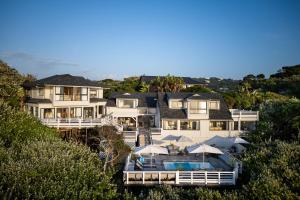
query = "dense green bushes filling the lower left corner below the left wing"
(0, 102, 118, 199)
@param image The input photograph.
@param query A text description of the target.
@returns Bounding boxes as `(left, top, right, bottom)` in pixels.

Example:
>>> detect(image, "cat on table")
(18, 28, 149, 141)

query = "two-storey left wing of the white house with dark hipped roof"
(26, 74, 106, 128)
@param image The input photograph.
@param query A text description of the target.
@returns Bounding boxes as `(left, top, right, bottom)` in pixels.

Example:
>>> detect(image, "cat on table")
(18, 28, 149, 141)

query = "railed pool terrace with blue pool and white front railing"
(123, 150, 239, 186)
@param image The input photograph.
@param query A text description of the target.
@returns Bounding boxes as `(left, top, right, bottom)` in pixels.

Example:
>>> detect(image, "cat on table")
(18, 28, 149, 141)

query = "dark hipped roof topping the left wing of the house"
(36, 74, 100, 87)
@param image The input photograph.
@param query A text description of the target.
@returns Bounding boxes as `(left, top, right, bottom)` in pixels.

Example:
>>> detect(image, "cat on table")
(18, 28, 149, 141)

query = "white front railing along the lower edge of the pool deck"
(123, 171, 236, 185)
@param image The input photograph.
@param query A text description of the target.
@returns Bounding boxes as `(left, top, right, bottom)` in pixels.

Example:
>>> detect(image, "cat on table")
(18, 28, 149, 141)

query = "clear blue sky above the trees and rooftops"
(0, 0, 300, 79)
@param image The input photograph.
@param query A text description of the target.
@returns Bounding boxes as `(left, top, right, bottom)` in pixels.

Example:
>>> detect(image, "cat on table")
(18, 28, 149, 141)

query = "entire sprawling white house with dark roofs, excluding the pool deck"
(26, 74, 258, 147)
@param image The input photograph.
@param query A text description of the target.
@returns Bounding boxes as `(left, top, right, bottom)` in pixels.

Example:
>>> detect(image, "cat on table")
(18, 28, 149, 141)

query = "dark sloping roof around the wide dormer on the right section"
(158, 92, 232, 120)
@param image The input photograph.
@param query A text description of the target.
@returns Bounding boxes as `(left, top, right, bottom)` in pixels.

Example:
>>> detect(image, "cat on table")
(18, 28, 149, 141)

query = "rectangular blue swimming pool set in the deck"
(164, 161, 213, 171)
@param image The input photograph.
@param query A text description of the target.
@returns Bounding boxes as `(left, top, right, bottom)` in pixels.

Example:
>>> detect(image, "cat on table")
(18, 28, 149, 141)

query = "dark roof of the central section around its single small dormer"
(106, 92, 157, 108)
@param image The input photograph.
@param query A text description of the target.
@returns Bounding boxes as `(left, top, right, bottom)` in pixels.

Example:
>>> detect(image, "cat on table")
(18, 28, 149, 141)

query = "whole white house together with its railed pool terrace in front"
(25, 74, 258, 186)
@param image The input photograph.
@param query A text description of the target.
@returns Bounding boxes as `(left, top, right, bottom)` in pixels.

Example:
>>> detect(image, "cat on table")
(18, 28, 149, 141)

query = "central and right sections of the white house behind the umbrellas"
(106, 93, 258, 147)
